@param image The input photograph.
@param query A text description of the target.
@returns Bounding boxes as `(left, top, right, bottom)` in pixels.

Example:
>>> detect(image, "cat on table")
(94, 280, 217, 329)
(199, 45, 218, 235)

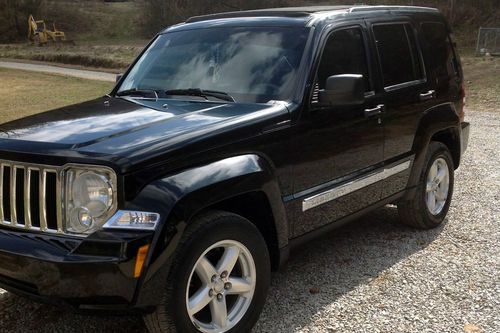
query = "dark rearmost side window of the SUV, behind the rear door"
(422, 22, 458, 79)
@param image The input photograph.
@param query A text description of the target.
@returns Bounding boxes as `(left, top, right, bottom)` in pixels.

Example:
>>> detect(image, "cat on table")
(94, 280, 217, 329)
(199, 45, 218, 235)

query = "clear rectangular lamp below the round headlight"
(104, 210, 160, 230)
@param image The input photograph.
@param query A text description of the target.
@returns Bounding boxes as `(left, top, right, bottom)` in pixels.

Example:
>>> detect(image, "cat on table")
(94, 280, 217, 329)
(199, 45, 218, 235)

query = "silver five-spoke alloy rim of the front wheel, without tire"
(186, 240, 256, 333)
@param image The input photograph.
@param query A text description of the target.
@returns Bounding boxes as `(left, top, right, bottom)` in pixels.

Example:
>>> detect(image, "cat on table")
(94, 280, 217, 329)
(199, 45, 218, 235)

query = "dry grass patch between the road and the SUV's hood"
(0, 68, 113, 123)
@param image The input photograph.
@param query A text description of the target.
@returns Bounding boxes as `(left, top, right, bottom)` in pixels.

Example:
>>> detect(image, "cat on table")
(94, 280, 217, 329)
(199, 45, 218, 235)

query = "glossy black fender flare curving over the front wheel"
(127, 154, 289, 306)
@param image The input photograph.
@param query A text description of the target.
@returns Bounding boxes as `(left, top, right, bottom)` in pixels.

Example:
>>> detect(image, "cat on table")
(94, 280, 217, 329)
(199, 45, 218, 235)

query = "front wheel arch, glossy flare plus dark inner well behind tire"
(130, 154, 289, 305)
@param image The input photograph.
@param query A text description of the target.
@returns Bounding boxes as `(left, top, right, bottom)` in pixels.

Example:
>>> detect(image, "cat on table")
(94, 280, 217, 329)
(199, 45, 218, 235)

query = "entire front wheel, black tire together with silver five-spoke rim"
(144, 211, 271, 333)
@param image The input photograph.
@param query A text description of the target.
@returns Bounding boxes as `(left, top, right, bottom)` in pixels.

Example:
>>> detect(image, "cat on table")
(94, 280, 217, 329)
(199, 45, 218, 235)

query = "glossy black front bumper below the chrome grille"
(0, 229, 152, 311)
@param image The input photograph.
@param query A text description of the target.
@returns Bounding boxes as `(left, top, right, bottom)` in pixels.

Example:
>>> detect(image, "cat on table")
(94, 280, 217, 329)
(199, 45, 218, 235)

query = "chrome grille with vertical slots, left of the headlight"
(0, 160, 63, 233)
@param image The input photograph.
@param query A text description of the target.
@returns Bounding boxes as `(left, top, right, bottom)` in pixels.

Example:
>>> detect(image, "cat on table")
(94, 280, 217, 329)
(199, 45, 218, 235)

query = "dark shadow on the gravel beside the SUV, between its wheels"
(253, 206, 447, 332)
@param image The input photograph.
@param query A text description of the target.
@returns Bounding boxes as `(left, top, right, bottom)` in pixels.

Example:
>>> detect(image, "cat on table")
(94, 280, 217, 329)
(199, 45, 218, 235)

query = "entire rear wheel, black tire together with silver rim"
(398, 141, 455, 229)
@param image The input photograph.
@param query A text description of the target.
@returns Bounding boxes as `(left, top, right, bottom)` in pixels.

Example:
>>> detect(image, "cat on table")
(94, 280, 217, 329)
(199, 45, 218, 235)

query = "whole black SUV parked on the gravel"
(0, 6, 469, 333)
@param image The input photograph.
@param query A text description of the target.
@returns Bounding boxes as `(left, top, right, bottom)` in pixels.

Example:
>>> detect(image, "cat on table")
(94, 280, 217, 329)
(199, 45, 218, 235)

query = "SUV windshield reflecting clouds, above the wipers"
(117, 27, 308, 103)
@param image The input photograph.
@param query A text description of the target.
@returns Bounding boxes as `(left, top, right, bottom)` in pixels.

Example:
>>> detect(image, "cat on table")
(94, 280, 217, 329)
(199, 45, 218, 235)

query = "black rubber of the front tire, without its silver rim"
(166, 215, 271, 333)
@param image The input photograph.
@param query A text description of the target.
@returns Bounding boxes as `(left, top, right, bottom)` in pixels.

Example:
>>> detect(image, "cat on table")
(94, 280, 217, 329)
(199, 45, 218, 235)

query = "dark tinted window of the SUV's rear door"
(373, 23, 423, 87)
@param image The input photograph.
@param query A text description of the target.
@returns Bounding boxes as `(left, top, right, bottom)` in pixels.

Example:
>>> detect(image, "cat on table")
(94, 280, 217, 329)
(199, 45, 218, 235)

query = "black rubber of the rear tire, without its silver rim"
(420, 143, 455, 226)
